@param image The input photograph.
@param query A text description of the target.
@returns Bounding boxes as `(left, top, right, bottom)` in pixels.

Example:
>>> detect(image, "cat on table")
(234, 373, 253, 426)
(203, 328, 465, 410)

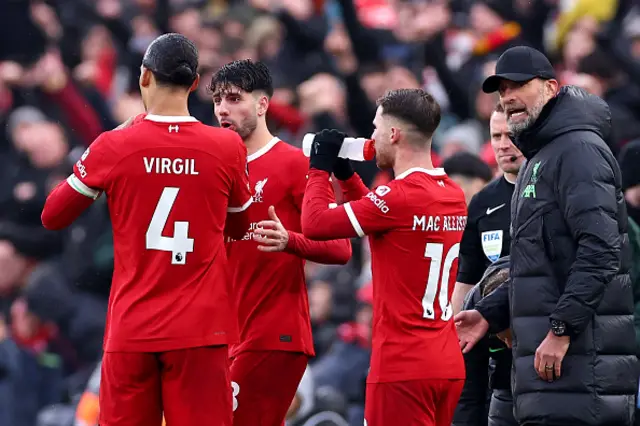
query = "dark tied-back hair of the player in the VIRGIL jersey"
(142, 33, 198, 88)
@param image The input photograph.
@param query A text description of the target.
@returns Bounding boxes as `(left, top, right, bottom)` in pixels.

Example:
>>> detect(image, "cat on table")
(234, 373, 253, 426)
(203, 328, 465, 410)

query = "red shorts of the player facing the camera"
(231, 351, 309, 426)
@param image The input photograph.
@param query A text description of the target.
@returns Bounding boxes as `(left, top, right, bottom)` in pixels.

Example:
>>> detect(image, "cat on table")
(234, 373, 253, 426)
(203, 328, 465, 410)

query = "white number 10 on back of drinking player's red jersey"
(422, 243, 460, 321)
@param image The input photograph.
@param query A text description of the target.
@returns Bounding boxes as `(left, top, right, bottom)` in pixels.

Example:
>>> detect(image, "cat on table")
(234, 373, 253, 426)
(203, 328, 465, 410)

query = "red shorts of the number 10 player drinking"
(364, 379, 464, 426)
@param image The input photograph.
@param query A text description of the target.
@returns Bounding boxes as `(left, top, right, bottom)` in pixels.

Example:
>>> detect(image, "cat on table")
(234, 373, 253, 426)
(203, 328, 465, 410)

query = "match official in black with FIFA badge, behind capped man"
(453, 103, 524, 426)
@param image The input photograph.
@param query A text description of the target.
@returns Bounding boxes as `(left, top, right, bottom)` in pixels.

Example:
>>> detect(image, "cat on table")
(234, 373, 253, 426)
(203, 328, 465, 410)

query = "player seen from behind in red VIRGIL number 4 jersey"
(42, 34, 252, 426)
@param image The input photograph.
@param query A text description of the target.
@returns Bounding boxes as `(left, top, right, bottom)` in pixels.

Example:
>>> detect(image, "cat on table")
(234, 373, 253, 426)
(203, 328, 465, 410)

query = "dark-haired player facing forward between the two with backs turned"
(210, 60, 351, 426)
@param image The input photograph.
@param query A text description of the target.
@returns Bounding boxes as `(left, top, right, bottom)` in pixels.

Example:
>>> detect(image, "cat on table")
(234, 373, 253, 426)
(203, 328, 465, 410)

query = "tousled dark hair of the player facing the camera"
(209, 59, 273, 97)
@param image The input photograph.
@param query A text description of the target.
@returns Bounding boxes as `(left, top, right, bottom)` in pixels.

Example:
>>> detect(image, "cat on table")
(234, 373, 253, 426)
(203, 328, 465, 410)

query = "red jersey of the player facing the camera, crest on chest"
(227, 138, 351, 356)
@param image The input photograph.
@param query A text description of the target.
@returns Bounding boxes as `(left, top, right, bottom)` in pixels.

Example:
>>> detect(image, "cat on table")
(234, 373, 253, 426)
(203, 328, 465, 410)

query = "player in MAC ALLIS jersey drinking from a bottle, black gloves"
(302, 89, 467, 426)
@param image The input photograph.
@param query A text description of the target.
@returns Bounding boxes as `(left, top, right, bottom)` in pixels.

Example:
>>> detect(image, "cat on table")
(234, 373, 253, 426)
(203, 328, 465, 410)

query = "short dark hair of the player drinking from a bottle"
(376, 89, 440, 138)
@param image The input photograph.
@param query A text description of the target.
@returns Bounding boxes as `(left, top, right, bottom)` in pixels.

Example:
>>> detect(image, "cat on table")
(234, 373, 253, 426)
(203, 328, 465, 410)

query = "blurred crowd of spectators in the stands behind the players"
(0, 0, 640, 426)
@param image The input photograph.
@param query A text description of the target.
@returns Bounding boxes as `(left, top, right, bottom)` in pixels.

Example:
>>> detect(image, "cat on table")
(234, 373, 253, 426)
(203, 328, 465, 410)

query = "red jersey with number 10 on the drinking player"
(303, 168, 467, 383)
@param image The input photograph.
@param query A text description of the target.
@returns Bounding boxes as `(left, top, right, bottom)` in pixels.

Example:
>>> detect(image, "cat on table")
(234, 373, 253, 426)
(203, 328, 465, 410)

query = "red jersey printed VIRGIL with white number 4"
(67, 115, 251, 352)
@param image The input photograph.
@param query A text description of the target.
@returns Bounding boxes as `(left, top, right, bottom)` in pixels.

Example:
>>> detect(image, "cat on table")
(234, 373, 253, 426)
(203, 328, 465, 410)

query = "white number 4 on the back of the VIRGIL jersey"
(146, 187, 193, 265)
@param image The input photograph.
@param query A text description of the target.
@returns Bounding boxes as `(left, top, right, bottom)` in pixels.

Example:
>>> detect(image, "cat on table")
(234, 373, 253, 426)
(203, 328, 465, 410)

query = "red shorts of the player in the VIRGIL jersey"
(100, 345, 233, 426)
